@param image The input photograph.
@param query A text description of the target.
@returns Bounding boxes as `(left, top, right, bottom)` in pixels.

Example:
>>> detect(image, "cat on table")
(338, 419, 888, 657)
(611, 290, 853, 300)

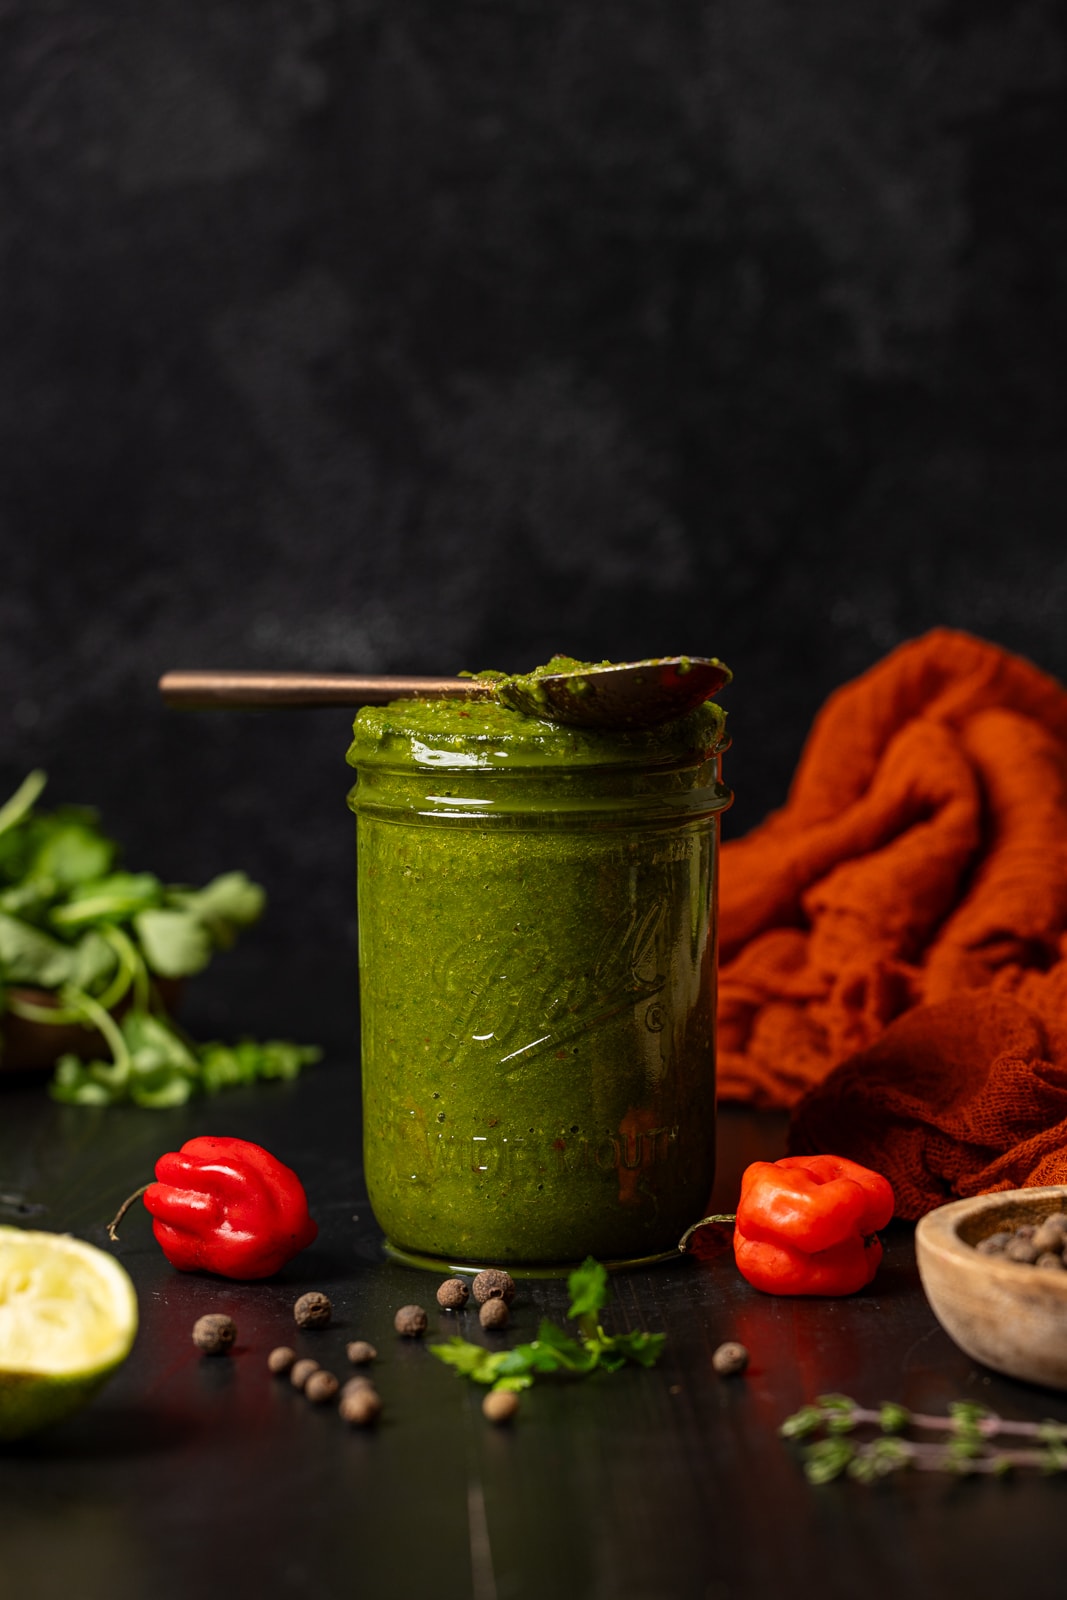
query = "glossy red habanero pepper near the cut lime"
(144, 1138, 318, 1278)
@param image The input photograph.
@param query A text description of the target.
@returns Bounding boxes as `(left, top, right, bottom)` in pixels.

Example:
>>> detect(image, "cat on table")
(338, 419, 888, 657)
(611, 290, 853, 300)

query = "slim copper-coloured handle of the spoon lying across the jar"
(160, 670, 493, 710)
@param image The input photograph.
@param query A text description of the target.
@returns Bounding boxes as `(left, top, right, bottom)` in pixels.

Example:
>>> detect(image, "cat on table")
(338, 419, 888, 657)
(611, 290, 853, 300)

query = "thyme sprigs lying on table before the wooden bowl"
(779, 1395, 1067, 1483)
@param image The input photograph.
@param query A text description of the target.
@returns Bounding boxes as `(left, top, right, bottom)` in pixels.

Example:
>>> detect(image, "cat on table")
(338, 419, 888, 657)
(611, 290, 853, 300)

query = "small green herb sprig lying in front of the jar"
(430, 1256, 665, 1390)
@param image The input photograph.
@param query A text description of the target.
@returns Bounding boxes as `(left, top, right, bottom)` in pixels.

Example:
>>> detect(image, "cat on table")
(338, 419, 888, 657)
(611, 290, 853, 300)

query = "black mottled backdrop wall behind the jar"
(0, 0, 1067, 1043)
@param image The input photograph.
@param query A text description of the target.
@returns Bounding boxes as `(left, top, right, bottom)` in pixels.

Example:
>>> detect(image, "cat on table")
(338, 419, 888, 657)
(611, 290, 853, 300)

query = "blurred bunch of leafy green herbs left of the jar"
(0, 771, 320, 1109)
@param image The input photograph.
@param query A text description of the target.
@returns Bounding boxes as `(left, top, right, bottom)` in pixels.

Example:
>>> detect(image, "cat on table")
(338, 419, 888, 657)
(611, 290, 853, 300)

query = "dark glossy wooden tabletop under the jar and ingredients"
(0, 1056, 1067, 1600)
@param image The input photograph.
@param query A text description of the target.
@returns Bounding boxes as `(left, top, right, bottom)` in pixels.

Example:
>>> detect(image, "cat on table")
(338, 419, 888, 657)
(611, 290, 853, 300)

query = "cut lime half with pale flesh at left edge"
(0, 1227, 138, 1440)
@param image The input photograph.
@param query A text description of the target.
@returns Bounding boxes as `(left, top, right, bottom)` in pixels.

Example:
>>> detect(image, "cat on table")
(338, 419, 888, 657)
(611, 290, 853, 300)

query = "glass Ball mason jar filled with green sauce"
(349, 701, 733, 1269)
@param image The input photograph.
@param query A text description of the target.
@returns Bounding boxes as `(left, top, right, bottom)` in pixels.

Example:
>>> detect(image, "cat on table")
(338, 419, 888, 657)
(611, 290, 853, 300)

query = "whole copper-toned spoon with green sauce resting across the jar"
(160, 656, 729, 730)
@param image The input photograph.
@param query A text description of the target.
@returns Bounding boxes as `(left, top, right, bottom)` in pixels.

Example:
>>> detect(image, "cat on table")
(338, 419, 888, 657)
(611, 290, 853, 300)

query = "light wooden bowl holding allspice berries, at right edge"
(915, 1184, 1067, 1389)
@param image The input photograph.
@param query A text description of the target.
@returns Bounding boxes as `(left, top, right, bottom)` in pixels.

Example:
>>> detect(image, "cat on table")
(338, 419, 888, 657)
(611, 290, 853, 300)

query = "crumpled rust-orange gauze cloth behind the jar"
(718, 629, 1067, 1216)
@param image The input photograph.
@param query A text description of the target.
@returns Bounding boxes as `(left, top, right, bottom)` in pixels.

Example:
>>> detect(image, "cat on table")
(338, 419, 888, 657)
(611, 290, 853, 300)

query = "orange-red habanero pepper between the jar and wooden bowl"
(734, 1155, 894, 1294)
